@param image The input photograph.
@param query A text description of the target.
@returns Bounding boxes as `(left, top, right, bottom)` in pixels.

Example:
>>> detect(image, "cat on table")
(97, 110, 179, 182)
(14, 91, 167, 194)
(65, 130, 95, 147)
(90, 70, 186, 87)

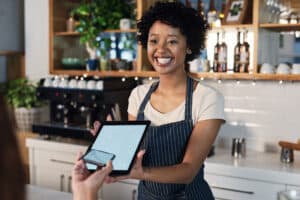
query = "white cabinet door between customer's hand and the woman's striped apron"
(102, 181, 138, 200)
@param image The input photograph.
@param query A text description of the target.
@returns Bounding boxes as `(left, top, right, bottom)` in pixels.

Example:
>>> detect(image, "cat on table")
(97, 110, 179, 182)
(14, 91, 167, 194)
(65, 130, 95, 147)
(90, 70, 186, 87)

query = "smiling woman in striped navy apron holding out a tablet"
(93, 2, 224, 200)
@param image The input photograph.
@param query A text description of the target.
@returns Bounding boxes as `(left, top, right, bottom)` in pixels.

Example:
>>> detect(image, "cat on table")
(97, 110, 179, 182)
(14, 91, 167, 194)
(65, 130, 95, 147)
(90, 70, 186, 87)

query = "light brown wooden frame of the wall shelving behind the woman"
(49, 0, 300, 80)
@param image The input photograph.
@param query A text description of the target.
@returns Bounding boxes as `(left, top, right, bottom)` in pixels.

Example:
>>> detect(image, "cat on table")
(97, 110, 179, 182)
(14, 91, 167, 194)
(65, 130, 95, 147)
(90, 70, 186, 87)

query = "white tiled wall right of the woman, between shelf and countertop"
(204, 80, 300, 151)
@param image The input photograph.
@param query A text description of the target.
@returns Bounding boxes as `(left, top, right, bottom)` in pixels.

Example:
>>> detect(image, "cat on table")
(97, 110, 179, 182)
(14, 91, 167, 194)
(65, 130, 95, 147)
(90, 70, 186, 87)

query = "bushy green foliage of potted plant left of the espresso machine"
(1, 78, 43, 108)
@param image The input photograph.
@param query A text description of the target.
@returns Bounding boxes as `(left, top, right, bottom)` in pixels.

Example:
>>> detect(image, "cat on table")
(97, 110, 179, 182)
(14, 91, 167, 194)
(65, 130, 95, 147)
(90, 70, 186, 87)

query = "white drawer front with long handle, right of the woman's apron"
(205, 174, 285, 200)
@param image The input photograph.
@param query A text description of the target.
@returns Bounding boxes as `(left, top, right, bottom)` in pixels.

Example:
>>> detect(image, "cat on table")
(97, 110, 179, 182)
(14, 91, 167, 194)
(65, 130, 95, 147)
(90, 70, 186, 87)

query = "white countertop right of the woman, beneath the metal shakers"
(205, 149, 300, 186)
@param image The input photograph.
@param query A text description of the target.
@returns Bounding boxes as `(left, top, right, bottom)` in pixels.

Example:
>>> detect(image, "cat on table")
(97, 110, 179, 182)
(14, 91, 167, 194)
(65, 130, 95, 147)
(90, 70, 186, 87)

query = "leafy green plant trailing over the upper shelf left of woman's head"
(71, 0, 135, 48)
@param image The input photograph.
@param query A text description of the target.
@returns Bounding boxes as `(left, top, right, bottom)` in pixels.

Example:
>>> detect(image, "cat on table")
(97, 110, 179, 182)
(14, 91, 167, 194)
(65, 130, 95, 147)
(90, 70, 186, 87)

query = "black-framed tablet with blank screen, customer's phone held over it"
(82, 121, 150, 175)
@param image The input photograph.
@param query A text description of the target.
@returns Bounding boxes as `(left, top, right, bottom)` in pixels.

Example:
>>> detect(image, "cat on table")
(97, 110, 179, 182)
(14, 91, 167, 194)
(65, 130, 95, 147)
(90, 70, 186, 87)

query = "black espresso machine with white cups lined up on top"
(32, 77, 139, 140)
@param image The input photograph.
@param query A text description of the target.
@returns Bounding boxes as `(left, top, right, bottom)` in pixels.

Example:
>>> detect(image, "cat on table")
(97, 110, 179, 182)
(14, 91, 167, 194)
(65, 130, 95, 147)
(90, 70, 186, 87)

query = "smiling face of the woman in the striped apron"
(147, 21, 187, 74)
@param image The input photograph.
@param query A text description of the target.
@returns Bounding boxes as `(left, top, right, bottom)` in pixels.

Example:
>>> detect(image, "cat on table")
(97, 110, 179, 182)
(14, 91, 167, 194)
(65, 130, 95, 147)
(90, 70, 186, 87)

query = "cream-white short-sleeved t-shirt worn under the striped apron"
(127, 83, 225, 126)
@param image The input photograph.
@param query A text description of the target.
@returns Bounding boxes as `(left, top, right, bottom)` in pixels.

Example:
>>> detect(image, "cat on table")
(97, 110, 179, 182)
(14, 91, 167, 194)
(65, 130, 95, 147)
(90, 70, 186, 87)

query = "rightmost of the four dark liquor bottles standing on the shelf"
(240, 31, 250, 72)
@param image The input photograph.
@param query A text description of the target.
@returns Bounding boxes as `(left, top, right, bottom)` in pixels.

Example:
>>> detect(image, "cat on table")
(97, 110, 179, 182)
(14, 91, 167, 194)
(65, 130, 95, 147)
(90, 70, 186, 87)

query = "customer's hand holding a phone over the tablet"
(72, 153, 112, 200)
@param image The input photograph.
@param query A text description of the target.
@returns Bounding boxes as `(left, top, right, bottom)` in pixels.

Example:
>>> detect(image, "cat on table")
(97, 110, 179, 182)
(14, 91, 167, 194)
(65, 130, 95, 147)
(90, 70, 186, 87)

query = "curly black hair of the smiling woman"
(137, 1, 208, 63)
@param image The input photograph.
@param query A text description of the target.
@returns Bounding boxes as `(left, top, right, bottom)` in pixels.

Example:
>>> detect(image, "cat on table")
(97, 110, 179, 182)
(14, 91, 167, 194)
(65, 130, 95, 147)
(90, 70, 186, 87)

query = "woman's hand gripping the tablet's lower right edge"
(105, 150, 146, 183)
